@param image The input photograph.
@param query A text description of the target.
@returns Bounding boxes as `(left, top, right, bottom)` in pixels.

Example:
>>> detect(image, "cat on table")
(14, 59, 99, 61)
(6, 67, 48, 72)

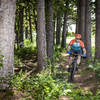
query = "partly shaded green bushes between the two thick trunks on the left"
(15, 40, 37, 62)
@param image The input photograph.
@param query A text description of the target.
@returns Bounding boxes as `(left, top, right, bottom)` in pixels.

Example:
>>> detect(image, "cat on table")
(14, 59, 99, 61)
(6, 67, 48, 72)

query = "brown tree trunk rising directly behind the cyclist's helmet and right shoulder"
(79, 0, 85, 42)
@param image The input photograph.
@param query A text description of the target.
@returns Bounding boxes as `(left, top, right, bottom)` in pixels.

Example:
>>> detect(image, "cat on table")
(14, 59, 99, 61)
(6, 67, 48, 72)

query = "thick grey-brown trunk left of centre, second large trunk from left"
(37, 0, 47, 70)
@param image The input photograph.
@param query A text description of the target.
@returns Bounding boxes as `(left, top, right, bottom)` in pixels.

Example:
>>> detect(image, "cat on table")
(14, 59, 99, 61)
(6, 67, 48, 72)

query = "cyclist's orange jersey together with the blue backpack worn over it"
(69, 39, 84, 51)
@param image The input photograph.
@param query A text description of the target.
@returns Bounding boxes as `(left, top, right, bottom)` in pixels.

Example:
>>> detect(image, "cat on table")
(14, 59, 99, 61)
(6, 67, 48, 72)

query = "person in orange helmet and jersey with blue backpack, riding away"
(67, 34, 86, 69)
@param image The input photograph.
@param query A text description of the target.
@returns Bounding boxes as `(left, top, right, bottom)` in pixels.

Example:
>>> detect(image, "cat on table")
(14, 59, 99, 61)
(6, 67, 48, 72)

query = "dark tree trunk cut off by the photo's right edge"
(95, 0, 100, 59)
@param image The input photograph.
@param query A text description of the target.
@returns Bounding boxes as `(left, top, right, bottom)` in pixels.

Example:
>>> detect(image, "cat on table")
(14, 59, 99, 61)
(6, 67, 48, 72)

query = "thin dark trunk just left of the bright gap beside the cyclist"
(61, 12, 67, 48)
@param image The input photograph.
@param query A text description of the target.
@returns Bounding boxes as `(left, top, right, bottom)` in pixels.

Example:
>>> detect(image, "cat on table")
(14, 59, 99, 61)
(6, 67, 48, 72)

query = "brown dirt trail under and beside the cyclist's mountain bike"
(61, 54, 100, 94)
